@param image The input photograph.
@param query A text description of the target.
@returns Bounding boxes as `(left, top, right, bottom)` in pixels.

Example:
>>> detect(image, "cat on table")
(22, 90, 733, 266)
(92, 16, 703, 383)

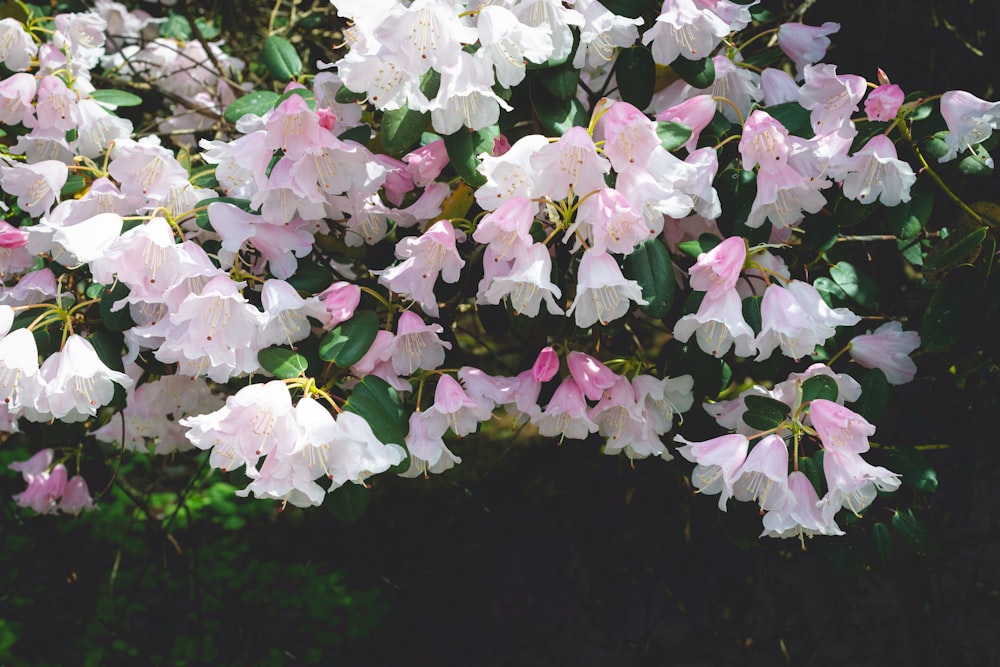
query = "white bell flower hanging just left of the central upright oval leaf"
(566, 249, 648, 329)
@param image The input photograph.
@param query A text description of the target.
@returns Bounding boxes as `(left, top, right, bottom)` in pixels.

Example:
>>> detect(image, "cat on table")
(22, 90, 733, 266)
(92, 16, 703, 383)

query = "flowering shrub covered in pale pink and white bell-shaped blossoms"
(0, 0, 1000, 556)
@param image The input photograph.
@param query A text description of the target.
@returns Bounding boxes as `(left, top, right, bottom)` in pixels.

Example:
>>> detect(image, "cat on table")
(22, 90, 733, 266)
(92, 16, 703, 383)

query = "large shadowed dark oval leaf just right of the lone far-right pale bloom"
(920, 266, 980, 352)
